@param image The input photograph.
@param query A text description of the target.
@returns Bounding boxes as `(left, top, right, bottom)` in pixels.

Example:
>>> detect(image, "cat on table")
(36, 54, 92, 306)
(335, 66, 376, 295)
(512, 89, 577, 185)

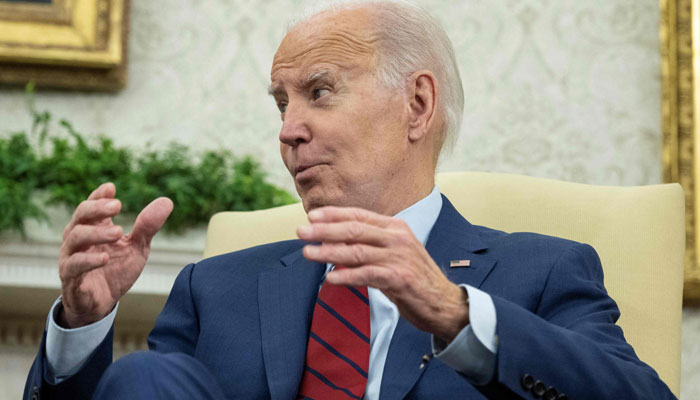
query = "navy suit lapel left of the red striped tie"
(258, 249, 324, 399)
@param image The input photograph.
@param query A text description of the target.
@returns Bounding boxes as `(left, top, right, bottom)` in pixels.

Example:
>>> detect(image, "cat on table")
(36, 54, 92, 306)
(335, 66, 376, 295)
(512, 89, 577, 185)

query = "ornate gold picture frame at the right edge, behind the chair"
(660, 0, 700, 304)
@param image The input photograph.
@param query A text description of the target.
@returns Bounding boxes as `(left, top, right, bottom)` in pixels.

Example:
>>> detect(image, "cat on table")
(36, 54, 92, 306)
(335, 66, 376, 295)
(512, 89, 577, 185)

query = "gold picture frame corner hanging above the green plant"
(0, 0, 129, 91)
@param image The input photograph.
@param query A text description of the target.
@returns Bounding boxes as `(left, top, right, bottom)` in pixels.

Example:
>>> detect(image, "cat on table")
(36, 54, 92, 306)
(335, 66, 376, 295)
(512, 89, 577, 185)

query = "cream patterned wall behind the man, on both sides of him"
(0, 0, 700, 399)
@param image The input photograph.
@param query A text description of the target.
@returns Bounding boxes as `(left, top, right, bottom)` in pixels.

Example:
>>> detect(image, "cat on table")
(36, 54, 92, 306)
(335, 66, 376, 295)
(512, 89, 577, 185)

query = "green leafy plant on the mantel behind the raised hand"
(0, 85, 295, 233)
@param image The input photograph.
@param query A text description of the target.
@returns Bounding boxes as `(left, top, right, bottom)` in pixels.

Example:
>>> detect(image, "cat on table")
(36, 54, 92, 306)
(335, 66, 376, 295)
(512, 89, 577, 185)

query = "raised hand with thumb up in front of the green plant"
(57, 183, 173, 328)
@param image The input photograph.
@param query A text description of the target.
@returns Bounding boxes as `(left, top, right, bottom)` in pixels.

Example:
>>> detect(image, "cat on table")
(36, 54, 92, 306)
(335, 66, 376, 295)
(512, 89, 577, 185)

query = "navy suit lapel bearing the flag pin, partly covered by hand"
(379, 196, 495, 400)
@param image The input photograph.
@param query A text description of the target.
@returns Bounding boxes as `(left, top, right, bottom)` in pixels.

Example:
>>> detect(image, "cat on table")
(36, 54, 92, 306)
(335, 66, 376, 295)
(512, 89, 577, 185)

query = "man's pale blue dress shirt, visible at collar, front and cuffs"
(46, 187, 497, 400)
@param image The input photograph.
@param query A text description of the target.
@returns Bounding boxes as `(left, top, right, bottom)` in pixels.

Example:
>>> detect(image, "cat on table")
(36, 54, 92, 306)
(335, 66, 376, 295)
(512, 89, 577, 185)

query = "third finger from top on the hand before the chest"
(303, 243, 386, 267)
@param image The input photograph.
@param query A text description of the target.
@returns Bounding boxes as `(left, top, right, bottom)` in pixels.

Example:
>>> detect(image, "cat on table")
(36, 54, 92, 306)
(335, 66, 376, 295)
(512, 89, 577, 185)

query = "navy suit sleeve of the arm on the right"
(482, 244, 675, 399)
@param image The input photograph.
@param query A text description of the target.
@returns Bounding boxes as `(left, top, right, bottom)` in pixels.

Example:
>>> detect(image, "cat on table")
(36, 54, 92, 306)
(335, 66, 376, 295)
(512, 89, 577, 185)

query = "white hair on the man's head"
(290, 0, 464, 159)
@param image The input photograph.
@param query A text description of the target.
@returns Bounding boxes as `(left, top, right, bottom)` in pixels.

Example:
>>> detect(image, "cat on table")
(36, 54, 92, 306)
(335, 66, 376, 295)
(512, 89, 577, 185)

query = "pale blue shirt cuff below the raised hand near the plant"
(45, 297, 119, 385)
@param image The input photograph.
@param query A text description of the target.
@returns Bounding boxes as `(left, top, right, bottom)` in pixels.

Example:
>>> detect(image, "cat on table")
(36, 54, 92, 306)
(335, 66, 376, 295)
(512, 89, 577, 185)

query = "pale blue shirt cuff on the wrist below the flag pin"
(432, 284, 498, 385)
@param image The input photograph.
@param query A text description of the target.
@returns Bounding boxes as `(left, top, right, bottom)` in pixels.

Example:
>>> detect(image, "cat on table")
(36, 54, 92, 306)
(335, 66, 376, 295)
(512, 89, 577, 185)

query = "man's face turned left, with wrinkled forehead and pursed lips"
(270, 9, 408, 212)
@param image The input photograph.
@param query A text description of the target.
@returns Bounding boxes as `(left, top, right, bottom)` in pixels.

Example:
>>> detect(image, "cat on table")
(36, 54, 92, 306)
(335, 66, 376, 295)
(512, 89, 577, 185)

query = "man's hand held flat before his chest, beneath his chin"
(297, 207, 469, 343)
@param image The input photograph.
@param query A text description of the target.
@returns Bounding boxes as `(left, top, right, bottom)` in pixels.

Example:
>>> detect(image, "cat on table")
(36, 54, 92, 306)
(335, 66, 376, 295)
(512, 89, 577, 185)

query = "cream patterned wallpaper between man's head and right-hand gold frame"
(442, 0, 660, 185)
